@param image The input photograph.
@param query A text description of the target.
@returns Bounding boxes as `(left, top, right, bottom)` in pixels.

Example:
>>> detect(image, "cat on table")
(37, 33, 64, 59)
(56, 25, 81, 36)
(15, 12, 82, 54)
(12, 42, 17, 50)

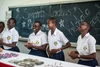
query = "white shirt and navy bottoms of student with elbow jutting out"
(48, 28, 69, 61)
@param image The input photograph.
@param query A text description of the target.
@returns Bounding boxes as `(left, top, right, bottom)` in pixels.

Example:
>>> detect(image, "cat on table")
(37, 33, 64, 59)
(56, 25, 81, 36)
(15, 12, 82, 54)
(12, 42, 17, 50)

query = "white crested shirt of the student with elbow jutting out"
(48, 28, 69, 50)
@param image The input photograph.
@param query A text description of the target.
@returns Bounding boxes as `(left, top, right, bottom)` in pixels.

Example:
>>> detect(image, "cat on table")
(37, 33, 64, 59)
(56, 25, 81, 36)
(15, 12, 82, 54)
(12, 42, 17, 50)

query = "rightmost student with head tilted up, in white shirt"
(68, 22, 98, 67)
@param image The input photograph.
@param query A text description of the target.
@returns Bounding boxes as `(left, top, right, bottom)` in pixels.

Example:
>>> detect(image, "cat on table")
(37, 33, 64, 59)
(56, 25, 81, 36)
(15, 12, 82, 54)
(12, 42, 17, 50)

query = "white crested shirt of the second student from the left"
(2, 27, 19, 49)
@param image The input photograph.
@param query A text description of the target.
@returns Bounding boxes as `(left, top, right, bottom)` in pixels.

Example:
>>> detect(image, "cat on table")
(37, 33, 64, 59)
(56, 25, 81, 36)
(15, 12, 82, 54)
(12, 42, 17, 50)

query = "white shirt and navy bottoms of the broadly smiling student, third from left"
(28, 30, 48, 57)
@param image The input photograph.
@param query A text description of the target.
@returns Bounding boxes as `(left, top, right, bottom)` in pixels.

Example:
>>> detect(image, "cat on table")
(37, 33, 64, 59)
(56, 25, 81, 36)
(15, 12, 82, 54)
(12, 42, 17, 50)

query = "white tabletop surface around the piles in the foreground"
(0, 50, 88, 67)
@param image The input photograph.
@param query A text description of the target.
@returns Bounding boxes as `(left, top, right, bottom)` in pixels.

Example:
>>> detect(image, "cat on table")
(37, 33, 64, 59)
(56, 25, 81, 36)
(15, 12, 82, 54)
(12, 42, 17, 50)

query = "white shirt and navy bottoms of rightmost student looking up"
(76, 33, 98, 67)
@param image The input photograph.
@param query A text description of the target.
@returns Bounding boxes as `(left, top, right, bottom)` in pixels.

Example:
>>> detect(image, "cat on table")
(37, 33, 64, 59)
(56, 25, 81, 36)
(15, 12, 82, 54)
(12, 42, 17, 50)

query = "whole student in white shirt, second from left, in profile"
(0, 18, 19, 52)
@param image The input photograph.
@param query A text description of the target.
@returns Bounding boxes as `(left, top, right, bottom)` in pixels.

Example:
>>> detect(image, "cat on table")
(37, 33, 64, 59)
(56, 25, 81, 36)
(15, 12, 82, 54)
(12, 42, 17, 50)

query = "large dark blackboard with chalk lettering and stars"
(9, 1, 100, 45)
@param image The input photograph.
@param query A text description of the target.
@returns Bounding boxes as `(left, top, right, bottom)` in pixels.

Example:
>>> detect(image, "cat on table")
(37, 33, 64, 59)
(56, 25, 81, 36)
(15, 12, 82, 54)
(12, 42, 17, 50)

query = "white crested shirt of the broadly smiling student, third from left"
(28, 30, 48, 49)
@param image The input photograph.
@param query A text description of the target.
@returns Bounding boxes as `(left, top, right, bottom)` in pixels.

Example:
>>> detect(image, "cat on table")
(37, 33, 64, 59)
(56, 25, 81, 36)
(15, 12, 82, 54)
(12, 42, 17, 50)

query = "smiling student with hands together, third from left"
(25, 21, 47, 57)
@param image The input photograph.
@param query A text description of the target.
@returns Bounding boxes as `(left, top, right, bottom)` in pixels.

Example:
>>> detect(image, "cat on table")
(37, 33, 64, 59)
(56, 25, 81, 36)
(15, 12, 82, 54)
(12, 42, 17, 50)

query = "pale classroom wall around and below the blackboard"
(0, 0, 100, 65)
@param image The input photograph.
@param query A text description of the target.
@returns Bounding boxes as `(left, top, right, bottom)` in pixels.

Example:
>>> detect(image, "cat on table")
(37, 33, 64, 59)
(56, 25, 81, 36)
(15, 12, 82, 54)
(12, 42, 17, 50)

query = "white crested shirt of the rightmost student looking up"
(76, 33, 96, 55)
